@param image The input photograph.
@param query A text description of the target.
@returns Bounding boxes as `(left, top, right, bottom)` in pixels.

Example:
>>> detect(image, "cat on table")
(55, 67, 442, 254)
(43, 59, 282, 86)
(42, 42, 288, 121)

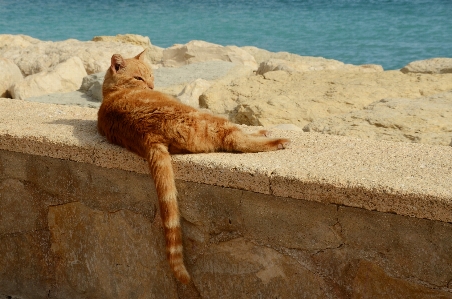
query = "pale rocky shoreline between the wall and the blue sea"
(0, 34, 452, 146)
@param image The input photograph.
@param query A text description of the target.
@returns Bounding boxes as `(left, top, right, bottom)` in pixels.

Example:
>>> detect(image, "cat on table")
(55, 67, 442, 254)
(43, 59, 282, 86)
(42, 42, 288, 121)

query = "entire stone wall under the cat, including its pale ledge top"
(0, 99, 452, 299)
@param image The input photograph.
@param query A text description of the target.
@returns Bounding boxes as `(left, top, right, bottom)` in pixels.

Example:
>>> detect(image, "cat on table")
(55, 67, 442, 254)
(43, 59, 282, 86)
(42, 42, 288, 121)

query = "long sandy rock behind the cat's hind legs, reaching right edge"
(200, 70, 452, 128)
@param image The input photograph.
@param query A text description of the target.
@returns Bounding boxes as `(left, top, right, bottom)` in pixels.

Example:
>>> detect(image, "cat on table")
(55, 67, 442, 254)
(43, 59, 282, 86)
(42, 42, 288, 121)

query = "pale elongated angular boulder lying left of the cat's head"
(11, 57, 87, 100)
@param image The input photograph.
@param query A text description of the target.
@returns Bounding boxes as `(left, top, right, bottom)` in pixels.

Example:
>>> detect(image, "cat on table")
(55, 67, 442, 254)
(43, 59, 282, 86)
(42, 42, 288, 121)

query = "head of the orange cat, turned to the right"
(104, 50, 154, 89)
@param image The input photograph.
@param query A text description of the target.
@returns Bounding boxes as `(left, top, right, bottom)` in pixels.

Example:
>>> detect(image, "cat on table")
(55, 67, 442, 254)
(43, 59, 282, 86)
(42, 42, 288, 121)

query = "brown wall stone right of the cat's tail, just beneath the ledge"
(178, 182, 343, 255)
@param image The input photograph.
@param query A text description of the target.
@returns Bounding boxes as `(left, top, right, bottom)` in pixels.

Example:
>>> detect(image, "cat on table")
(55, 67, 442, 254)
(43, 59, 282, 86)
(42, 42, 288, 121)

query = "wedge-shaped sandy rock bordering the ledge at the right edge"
(304, 91, 452, 146)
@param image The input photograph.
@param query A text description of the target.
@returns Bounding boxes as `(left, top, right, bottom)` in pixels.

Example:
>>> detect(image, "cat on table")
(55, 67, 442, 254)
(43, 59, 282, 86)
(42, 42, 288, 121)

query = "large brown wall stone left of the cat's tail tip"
(48, 203, 177, 298)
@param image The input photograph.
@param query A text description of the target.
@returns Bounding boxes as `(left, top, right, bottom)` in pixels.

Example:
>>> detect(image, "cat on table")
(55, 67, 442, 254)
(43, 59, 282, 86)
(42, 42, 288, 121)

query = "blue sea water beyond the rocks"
(0, 0, 452, 69)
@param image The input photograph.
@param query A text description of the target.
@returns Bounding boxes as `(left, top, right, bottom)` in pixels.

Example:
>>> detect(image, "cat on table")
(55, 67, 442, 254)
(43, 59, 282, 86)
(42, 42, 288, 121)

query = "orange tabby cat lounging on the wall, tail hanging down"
(98, 52, 290, 283)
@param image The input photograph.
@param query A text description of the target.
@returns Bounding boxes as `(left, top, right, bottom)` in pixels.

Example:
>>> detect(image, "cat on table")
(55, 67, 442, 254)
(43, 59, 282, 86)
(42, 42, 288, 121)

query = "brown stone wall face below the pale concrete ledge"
(0, 150, 452, 298)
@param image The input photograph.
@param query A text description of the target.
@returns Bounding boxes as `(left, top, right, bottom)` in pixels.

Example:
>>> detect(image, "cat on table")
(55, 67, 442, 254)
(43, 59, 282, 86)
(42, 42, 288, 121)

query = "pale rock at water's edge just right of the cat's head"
(163, 40, 258, 69)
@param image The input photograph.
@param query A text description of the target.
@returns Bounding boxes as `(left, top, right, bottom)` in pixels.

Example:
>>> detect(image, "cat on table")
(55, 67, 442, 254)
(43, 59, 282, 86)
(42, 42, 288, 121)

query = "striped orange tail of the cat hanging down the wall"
(148, 143, 190, 284)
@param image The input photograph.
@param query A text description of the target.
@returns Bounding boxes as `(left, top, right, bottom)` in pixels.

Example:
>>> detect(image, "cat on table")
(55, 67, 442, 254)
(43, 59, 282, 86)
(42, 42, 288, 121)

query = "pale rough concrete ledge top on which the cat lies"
(0, 99, 452, 222)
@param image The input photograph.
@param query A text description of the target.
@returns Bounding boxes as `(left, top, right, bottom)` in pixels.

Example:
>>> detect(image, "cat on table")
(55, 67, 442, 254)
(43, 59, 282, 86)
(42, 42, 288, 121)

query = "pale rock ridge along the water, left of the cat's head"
(0, 35, 143, 76)
